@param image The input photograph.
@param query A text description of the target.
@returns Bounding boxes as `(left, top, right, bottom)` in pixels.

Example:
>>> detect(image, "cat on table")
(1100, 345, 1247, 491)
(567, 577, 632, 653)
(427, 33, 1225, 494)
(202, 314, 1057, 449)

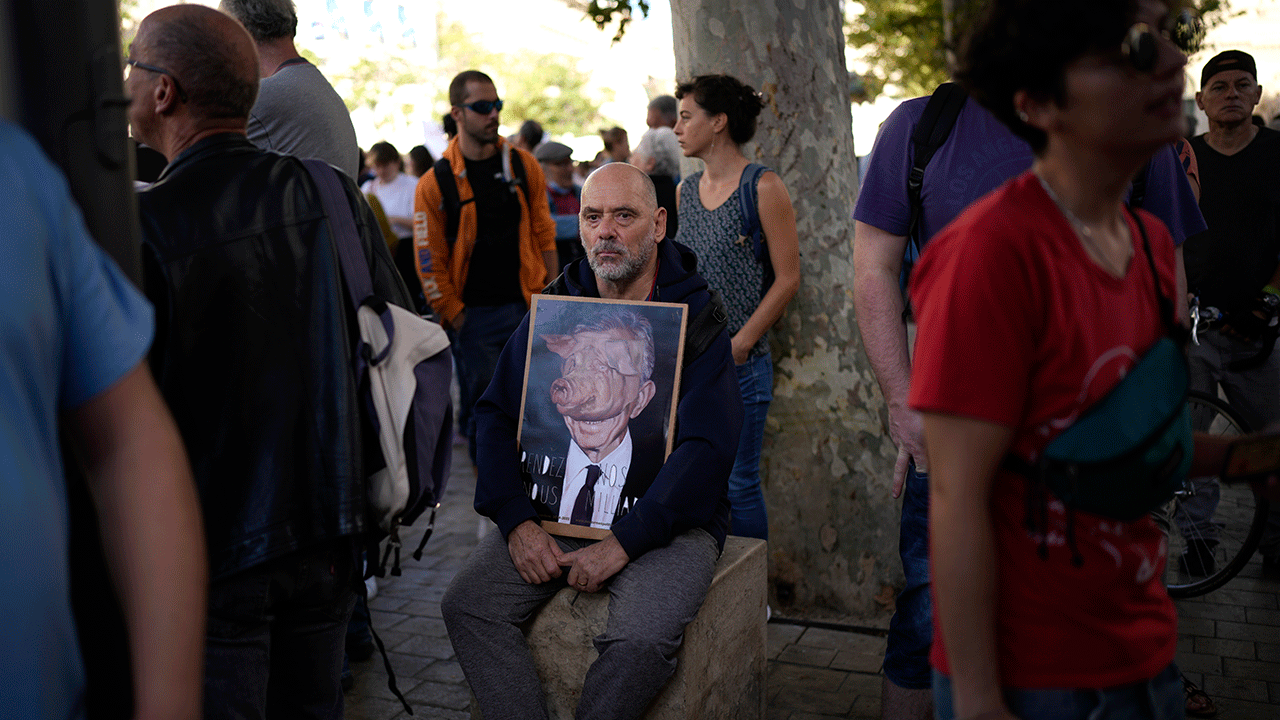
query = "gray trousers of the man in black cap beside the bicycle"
(1179, 329, 1280, 555)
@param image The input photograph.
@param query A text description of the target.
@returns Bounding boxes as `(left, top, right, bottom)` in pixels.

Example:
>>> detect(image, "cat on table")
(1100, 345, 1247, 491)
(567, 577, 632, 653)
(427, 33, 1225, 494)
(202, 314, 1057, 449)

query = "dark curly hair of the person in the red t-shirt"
(956, 0, 1181, 155)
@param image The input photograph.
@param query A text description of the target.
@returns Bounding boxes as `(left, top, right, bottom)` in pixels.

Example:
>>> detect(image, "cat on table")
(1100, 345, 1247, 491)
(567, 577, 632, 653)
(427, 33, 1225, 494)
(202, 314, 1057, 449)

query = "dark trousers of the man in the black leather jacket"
(205, 541, 356, 720)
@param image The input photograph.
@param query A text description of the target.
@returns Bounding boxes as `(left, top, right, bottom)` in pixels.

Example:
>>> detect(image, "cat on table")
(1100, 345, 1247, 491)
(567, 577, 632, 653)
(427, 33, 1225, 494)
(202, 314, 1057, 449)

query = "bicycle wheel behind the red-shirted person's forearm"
(1156, 391, 1268, 598)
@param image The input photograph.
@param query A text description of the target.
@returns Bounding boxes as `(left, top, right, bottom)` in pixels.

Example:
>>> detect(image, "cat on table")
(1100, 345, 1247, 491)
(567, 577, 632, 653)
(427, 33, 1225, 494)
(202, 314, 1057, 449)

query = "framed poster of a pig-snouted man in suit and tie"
(516, 295, 687, 538)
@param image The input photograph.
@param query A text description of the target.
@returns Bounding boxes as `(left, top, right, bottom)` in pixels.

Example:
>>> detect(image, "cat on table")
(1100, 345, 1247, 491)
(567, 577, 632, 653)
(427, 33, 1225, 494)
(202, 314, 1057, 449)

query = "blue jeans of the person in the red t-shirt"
(933, 665, 1187, 720)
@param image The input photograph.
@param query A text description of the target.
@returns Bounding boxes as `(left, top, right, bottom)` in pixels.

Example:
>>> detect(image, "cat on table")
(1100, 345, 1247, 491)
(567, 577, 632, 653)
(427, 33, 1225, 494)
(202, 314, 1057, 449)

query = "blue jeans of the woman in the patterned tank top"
(728, 352, 773, 541)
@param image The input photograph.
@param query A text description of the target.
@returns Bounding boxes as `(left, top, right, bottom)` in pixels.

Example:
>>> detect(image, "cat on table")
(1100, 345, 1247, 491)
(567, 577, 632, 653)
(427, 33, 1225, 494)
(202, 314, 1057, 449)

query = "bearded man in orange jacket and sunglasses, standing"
(413, 70, 559, 462)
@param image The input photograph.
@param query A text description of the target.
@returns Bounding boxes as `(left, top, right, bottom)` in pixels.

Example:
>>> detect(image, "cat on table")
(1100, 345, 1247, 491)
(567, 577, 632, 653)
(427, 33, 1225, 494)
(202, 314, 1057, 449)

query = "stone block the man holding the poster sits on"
(471, 537, 768, 720)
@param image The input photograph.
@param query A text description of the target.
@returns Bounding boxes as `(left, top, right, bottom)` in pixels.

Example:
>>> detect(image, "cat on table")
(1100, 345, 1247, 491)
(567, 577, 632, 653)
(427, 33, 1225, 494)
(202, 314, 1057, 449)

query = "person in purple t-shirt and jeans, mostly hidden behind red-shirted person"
(854, 92, 1204, 717)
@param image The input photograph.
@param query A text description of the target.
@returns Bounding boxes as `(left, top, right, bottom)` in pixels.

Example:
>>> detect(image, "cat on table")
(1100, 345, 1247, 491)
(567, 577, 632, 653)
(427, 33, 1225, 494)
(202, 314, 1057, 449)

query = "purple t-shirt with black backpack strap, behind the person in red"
(854, 96, 1204, 258)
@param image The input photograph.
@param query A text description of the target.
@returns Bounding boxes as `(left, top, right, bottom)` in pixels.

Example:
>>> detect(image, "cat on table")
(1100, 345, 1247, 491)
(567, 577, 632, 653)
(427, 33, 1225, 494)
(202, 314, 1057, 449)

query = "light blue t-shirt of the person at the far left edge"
(0, 122, 154, 720)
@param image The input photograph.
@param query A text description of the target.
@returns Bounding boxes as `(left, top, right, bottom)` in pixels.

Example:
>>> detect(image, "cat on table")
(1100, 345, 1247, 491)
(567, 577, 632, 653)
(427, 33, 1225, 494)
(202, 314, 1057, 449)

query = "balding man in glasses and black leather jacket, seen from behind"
(125, 5, 408, 717)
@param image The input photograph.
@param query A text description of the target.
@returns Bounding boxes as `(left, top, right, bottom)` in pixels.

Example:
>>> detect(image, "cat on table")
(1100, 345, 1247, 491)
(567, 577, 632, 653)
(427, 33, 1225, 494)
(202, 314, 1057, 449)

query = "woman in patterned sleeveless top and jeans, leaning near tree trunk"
(676, 76, 800, 539)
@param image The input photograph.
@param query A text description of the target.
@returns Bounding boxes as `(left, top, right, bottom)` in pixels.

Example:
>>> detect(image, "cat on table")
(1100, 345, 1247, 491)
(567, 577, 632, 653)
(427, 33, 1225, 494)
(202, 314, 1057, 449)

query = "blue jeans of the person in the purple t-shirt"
(884, 461, 933, 691)
